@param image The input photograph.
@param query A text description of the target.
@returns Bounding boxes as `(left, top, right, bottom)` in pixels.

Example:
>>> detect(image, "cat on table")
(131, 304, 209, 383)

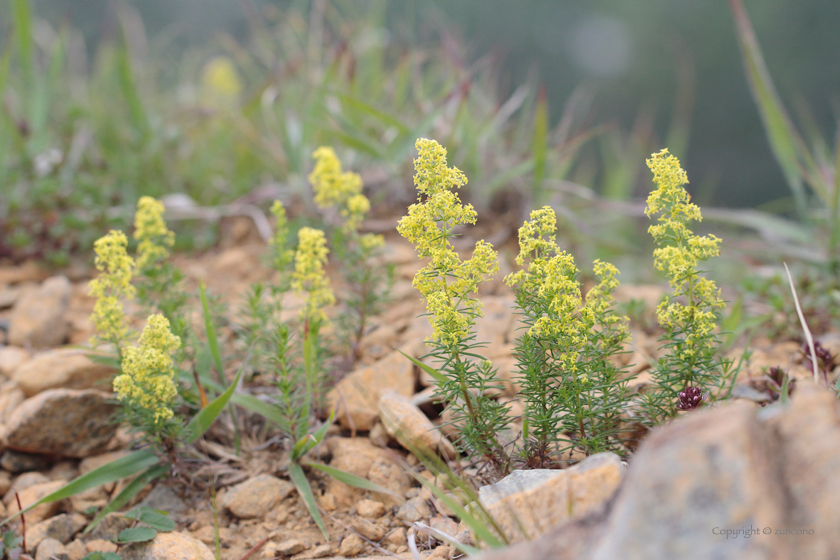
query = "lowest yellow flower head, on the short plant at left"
(114, 314, 181, 426)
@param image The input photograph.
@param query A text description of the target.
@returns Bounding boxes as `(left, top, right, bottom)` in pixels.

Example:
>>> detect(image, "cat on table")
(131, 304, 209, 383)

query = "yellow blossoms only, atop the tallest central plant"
(397, 138, 499, 345)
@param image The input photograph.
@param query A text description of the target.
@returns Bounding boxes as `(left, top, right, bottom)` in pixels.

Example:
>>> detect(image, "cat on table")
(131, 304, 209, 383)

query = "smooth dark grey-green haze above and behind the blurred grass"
(2, 0, 840, 207)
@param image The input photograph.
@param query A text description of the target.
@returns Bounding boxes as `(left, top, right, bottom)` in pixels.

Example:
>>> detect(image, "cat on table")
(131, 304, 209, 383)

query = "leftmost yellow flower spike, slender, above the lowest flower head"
(89, 230, 135, 347)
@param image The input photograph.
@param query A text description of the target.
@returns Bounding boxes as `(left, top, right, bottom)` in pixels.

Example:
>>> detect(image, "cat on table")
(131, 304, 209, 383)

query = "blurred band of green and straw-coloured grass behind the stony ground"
(0, 0, 616, 263)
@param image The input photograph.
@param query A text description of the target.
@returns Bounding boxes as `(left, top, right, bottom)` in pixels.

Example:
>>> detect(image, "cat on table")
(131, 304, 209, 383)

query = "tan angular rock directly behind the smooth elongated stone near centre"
(327, 351, 414, 431)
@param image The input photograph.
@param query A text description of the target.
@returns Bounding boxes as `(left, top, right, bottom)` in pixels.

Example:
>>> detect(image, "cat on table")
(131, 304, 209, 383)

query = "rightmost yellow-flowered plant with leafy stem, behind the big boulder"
(645, 150, 732, 423)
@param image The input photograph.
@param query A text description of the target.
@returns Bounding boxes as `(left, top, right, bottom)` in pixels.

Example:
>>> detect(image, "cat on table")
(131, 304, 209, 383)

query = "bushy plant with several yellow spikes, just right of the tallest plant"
(505, 206, 628, 460)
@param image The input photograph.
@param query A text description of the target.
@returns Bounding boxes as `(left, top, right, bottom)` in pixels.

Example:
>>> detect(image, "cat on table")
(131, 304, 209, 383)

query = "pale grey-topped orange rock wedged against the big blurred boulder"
(479, 453, 622, 542)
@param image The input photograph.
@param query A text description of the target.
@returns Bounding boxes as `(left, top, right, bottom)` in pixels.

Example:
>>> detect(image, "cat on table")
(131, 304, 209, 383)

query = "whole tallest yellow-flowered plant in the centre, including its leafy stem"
(397, 139, 510, 472)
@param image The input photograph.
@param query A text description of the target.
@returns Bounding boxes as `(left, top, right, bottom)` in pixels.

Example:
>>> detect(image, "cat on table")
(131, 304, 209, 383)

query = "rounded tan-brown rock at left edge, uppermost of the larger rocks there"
(9, 276, 73, 348)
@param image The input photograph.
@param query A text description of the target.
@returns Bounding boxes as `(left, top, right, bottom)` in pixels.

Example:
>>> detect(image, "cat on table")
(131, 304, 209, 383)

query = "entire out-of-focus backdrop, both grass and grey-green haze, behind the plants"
(0, 0, 840, 268)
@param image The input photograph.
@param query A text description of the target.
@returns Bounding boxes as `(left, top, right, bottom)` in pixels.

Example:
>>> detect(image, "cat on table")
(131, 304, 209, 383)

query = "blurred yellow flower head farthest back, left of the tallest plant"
(309, 146, 370, 232)
